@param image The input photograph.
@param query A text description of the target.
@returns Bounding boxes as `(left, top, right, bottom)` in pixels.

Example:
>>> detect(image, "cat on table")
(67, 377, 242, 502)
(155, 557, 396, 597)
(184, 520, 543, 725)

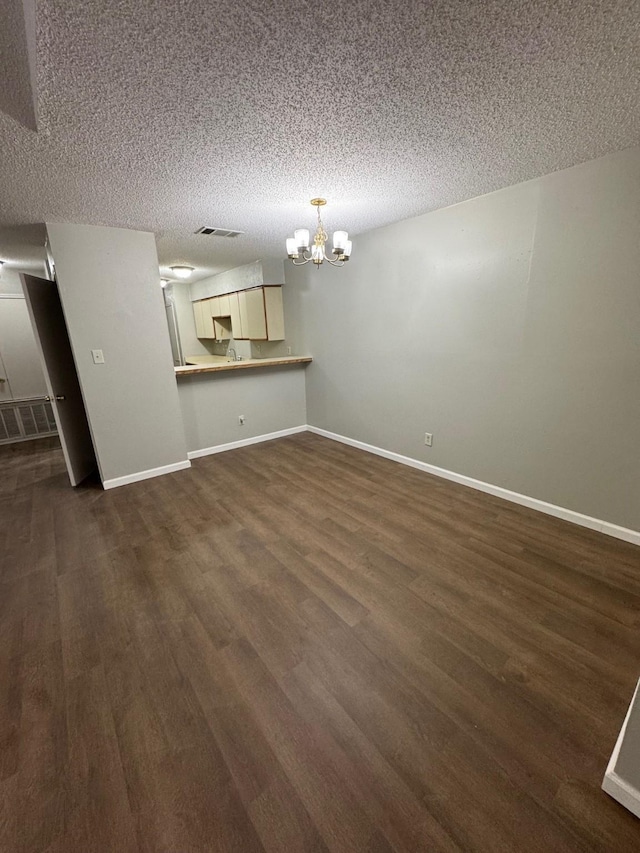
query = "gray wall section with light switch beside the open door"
(47, 223, 186, 480)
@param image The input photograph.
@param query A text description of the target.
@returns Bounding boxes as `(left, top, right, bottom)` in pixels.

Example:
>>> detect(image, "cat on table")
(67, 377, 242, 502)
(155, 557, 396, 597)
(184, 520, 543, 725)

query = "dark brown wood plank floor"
(0, 433, 640, 853)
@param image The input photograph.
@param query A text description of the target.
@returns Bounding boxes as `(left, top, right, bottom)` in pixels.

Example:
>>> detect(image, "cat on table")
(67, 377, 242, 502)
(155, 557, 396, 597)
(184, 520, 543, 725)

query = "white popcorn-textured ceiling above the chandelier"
(0, 0, 640, 277)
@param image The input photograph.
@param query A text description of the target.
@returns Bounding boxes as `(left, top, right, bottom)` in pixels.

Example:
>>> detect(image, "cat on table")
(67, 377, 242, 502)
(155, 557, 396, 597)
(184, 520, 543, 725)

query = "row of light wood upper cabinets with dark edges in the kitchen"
(193, 285, 284, 341)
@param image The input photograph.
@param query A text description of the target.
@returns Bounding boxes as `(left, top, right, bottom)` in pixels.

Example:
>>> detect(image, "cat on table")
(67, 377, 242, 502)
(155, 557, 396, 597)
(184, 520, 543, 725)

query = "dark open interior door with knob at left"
(20, 275, 96, 486)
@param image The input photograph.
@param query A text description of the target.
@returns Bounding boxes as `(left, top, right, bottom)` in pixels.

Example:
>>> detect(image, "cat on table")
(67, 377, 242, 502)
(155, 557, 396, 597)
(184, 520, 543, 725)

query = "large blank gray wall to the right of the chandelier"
(285, 148, 640, 530)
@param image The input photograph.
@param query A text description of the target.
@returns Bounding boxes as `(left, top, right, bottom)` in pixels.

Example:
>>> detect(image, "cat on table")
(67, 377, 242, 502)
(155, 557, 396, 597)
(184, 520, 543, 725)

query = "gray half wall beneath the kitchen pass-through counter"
(178, 366, 307, 450)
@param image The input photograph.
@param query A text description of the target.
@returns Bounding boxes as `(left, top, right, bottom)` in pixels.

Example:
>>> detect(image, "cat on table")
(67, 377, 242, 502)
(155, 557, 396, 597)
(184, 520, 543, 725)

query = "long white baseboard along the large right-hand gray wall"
(307, 425, 640, 545)
